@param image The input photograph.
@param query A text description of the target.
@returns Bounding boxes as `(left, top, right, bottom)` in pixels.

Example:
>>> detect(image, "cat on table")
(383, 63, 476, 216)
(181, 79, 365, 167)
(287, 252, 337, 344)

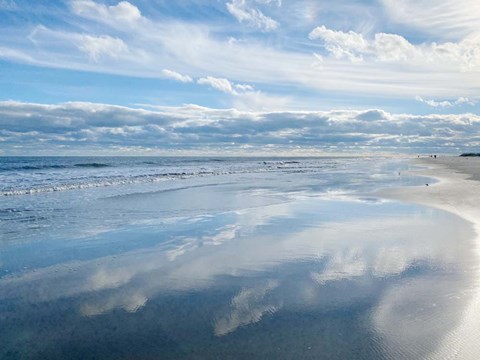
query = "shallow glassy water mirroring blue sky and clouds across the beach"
(0, 159, 477, 359)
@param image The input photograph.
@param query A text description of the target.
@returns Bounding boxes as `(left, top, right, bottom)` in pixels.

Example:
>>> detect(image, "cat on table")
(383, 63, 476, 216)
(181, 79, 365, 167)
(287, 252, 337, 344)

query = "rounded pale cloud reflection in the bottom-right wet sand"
(372, 275, 472, 359)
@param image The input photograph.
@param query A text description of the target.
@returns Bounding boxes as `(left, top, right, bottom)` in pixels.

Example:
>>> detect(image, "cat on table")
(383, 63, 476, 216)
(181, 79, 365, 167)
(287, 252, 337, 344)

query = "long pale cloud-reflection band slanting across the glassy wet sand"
(0, 211, 472, 310)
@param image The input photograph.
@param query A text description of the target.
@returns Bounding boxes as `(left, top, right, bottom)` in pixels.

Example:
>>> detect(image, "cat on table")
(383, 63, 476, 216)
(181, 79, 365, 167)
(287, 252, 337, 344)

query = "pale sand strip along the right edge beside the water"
(380, 157, 480, 359)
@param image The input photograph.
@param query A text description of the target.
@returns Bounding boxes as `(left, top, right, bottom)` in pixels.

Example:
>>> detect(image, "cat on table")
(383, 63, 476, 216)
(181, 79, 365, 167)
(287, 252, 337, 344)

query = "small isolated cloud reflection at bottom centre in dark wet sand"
(215, 280, 280, 336)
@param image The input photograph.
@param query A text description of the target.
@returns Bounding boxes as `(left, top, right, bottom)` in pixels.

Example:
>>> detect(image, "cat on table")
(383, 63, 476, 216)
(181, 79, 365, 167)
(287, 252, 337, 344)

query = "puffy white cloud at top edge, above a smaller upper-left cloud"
(71, 0, 142, 27)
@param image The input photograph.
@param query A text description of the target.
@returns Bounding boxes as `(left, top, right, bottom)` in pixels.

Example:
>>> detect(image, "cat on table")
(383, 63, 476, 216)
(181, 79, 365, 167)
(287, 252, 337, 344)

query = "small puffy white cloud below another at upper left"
(77, 35, 128, 61)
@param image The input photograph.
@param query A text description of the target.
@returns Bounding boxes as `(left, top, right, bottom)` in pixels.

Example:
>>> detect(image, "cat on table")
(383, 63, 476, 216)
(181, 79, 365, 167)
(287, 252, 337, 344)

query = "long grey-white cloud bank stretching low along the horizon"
(0, 101, 480, 155)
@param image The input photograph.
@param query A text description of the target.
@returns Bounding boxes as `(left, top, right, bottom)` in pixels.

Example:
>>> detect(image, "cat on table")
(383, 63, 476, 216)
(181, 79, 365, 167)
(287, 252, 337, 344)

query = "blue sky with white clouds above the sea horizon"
(0, 0, 480, 155)
